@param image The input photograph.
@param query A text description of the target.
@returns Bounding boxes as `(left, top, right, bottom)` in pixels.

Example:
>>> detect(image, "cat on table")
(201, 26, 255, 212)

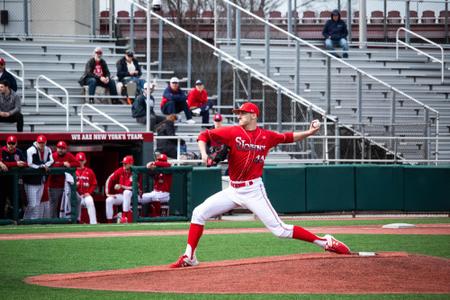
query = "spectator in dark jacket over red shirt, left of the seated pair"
(79, 47, 119, 103)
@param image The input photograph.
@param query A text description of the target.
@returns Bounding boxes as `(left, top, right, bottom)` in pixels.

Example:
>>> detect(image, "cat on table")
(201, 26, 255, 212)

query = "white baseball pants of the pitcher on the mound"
(191, 178, 294, 238)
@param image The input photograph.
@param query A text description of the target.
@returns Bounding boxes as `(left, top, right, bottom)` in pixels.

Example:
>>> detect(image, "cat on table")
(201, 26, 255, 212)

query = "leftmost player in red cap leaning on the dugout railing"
(0, 135, 27, 219)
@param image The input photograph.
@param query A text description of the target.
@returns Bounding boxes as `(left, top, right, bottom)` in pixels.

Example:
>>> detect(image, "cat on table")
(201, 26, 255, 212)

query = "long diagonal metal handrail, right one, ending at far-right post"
(214, 0, 439, 161)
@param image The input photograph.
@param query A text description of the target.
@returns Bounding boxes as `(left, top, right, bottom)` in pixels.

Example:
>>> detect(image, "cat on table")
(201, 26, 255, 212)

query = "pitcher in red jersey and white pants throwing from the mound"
(170, 102, 350, 268)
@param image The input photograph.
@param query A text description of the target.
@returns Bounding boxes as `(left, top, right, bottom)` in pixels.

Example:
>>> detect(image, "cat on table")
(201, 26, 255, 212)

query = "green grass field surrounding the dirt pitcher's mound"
(0, 218, 450, 300)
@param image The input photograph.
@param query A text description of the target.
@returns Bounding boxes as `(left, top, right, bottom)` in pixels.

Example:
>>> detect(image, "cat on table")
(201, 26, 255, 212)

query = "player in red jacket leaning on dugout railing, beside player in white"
(48, 141, 80, 218)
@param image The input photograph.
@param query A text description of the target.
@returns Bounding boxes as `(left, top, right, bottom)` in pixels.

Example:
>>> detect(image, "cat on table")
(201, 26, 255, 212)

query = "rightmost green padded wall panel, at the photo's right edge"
(403, 166, 450, 211)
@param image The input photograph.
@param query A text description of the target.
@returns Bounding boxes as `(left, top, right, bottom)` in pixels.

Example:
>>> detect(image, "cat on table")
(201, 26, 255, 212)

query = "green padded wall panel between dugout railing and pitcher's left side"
(192, 167, 222, 209)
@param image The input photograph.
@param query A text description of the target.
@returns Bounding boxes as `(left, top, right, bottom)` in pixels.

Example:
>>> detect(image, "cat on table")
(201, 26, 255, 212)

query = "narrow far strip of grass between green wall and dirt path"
(0, 218, 450, 234)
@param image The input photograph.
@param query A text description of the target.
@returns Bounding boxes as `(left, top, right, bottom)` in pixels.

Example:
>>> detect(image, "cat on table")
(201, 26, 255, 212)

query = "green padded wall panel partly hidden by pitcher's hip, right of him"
(263, 166, 306, 213)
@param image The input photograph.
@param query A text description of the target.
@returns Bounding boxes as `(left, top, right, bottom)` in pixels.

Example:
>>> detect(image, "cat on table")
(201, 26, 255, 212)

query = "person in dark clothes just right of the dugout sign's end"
(156, 114, 185, 158)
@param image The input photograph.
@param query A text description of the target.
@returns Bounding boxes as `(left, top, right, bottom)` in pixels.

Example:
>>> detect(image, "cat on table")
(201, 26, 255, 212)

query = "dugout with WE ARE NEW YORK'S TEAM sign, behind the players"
(0, 132, 154, 222)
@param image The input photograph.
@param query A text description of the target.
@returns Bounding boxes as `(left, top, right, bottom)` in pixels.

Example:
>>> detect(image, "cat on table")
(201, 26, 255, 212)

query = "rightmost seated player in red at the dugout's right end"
(139, 154, 172, 217)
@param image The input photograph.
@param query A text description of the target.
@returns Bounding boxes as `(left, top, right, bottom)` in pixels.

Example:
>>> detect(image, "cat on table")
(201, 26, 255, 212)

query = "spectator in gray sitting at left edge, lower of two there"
(0, 80, 23, 132)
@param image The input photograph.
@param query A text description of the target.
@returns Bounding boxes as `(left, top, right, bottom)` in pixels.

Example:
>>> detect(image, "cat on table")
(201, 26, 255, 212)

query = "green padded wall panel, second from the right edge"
(355, 165, 404, 210)
